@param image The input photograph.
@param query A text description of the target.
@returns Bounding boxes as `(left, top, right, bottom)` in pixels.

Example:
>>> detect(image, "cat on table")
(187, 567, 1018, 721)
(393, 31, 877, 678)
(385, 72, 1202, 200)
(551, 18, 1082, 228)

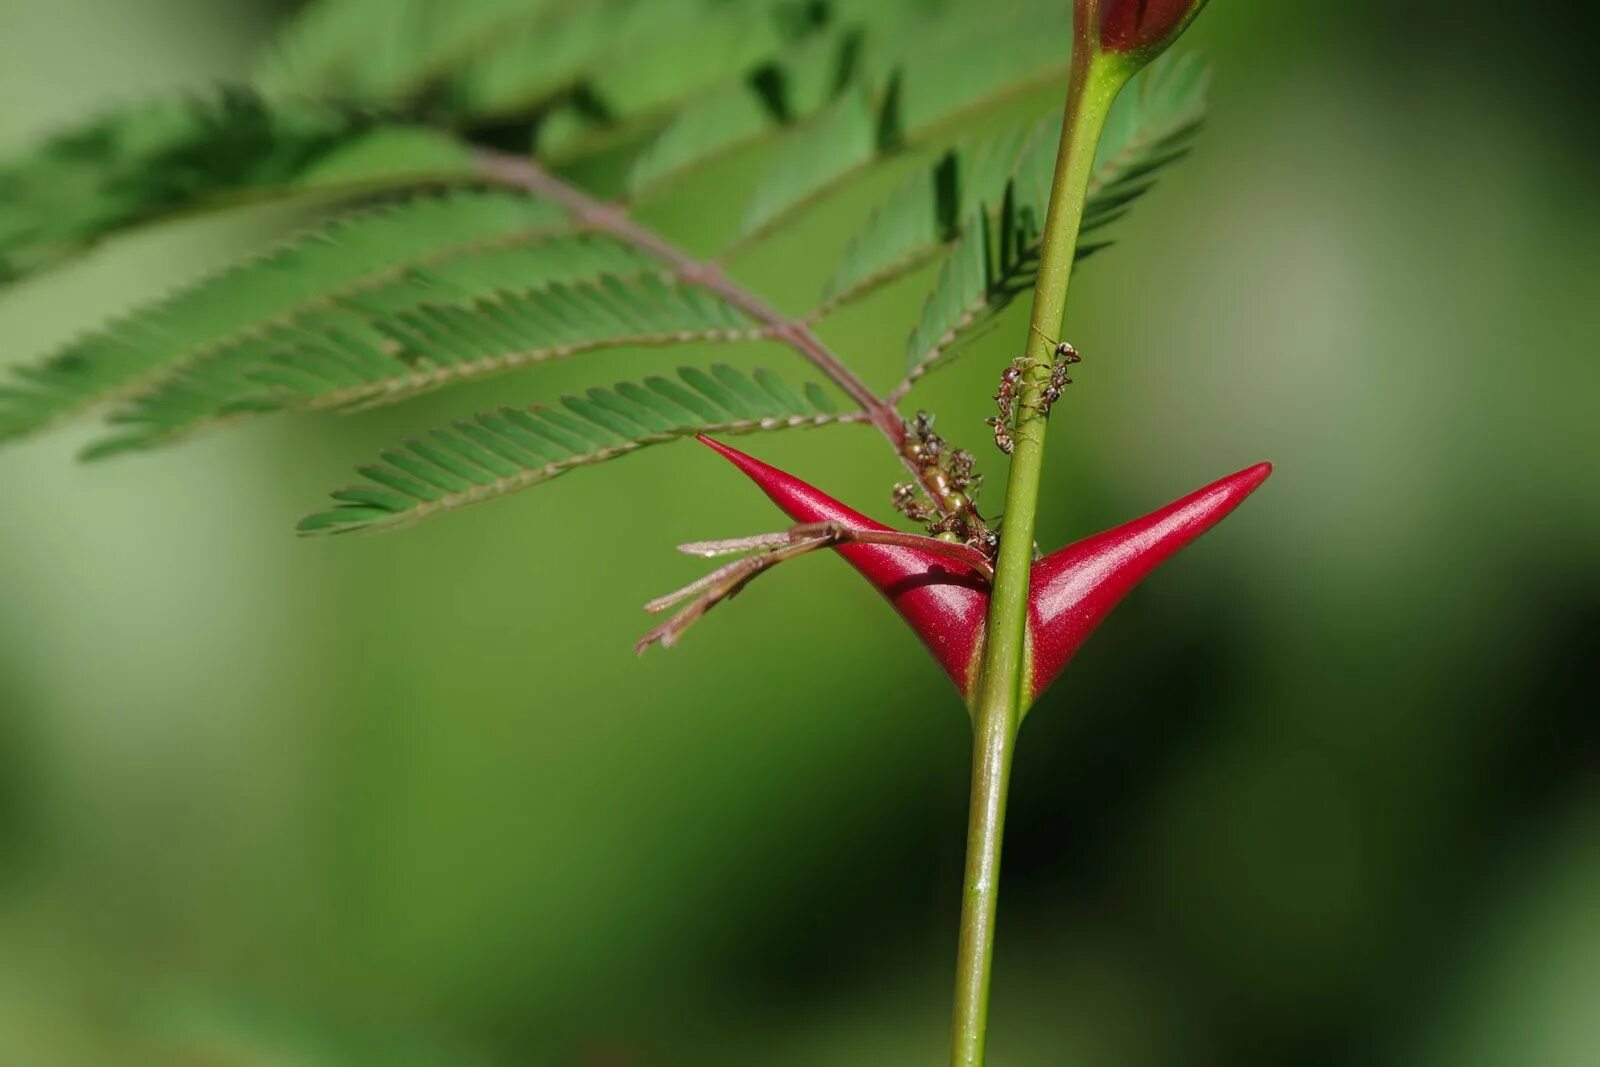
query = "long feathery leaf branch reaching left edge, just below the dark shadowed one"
(0, 192, 563, 440)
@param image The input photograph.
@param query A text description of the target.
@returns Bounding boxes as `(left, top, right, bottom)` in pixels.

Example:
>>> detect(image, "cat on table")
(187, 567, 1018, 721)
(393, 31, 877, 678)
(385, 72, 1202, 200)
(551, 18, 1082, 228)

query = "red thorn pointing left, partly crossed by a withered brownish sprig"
(699, 435, 989, 696)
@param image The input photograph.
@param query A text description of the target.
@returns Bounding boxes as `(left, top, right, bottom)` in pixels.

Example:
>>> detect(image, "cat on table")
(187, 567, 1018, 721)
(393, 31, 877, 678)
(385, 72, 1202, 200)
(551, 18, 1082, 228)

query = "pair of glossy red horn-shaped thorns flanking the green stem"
(699, 435, 1272, 697)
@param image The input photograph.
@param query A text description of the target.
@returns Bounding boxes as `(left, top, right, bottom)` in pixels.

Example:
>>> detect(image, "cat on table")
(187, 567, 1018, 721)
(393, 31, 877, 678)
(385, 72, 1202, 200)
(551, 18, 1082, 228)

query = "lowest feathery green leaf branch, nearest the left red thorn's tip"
(299, 363, 856, 534)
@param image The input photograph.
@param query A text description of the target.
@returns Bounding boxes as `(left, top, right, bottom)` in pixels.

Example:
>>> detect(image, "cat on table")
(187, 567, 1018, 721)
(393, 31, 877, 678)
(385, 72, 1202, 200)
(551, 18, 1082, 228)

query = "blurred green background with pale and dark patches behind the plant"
(0, 0, 1600, 1067)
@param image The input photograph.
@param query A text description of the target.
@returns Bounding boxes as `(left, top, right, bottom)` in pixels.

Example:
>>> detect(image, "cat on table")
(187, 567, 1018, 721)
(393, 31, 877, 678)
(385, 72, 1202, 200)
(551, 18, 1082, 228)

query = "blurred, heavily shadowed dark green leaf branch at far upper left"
(0, 90, 470, 283)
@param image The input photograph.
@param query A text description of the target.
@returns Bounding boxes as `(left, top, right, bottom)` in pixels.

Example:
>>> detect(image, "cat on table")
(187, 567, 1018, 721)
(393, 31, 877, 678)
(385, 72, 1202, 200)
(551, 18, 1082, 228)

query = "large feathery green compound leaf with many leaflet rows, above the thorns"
(0, 0, 1205, 559)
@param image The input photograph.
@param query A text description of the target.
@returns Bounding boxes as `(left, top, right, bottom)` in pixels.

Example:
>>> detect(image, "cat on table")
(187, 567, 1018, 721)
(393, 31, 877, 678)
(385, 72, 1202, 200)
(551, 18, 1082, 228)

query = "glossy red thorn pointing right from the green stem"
(1027, 462, 1272, 697)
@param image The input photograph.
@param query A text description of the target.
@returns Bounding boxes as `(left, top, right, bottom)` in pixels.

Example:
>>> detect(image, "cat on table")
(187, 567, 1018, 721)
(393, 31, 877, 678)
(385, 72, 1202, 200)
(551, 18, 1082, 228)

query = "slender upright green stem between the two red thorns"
(950, 46, 1130, 1067)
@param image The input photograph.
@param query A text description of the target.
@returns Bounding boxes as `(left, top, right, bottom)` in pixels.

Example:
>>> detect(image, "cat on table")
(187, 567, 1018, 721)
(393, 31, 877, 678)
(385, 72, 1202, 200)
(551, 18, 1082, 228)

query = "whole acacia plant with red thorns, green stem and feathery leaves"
(0, 0, 1269, 1064)
